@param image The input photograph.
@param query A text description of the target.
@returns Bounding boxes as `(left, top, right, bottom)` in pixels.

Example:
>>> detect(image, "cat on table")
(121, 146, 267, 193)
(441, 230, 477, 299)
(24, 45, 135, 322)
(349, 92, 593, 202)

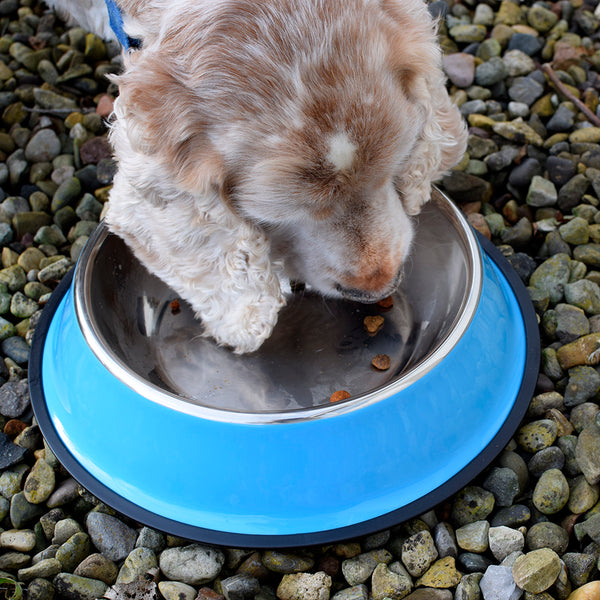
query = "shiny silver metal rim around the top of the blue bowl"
(73, 188, 483, 424)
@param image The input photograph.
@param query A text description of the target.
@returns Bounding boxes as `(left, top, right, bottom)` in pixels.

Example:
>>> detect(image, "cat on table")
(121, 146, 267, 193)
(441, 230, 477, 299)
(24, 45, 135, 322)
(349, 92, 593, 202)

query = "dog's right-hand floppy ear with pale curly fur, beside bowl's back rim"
(382, 0, 467, 215)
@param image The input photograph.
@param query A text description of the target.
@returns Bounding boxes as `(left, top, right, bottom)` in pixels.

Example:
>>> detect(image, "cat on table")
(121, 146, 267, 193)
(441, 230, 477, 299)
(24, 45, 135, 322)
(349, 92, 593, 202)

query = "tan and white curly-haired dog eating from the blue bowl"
(47, 0, 467, 353)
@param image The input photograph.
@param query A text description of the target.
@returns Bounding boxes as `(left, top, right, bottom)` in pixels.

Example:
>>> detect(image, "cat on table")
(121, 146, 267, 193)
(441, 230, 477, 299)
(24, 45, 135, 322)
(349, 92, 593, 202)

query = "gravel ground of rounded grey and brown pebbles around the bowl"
(0, 0, 600, 600)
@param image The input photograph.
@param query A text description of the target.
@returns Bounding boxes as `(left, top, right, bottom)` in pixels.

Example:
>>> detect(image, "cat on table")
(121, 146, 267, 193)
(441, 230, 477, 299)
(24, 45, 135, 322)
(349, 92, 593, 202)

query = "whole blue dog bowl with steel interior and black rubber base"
(30, 190, 539, 547)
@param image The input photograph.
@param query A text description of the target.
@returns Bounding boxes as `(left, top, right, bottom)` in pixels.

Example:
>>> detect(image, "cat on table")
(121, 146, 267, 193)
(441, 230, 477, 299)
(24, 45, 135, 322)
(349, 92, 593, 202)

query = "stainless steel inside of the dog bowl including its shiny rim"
(74, 190, 482, 422)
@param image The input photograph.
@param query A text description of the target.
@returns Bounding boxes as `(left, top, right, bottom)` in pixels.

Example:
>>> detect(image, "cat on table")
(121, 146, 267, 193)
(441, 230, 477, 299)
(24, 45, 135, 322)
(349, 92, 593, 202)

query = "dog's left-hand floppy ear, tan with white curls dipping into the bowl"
(106, 50, 285, 353)
